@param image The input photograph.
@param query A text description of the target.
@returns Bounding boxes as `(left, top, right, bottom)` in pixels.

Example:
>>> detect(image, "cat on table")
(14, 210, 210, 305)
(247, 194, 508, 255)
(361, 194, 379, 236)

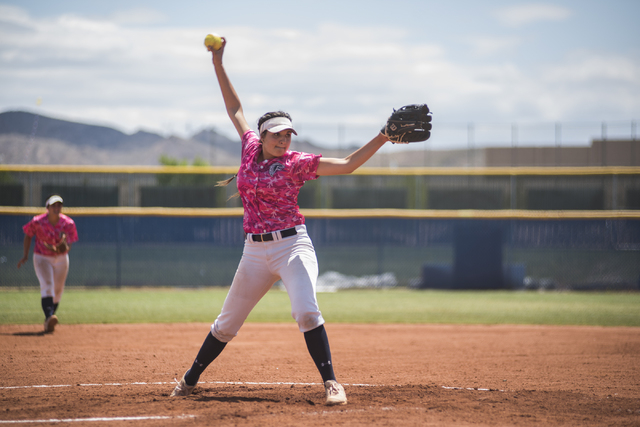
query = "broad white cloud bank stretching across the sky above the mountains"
(0, 5, 640, 147)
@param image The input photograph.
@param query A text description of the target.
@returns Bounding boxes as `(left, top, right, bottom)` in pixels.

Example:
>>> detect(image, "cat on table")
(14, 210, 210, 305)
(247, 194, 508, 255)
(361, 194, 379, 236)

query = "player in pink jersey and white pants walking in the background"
(18, 195, 78, 332)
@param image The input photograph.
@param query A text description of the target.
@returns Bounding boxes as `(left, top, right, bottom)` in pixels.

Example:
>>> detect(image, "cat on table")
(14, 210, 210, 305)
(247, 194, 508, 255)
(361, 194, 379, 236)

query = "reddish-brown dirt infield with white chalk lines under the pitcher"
(0, 319, 640, 427)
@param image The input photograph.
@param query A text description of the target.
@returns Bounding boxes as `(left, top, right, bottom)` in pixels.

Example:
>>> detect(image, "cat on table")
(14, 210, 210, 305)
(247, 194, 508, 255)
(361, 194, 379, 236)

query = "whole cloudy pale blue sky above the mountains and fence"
(0, 0, 640, 148)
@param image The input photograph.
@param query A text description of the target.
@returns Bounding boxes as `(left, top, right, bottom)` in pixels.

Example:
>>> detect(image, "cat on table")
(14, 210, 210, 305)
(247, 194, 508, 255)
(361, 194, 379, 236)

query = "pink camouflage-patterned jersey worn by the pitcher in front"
(237, 130, 322, 234)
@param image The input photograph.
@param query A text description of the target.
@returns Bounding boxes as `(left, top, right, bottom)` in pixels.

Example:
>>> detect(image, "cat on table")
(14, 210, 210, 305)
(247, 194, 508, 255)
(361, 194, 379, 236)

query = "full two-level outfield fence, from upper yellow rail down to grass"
(0, 165, 640, 290)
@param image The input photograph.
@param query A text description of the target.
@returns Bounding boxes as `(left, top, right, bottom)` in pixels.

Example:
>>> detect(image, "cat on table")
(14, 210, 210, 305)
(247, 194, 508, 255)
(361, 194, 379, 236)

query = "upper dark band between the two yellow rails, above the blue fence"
(0, 165, 640, 210)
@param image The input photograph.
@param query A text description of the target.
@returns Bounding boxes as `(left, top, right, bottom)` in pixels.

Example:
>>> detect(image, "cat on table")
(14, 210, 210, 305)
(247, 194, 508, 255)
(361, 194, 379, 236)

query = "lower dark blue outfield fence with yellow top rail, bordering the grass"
(0, 207, 640, 291)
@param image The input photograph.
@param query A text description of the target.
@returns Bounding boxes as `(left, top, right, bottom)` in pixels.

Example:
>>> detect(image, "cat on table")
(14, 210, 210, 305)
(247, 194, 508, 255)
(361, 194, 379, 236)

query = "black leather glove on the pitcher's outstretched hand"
(380, 104, 431, 144)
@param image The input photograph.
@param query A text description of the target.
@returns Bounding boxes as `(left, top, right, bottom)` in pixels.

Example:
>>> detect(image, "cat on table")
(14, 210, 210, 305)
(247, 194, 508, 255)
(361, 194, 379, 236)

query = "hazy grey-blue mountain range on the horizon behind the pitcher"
(0, 111, 376, 166)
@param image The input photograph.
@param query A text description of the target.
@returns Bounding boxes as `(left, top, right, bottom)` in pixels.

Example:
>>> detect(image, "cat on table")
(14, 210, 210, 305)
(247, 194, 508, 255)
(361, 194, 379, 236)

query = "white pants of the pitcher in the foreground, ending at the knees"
(211, 225, 324, 342)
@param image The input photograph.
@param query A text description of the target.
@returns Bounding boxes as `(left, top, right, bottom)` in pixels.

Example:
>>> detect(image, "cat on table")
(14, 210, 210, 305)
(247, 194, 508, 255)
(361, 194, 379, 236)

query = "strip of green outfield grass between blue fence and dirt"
(0, 288, 640, 327)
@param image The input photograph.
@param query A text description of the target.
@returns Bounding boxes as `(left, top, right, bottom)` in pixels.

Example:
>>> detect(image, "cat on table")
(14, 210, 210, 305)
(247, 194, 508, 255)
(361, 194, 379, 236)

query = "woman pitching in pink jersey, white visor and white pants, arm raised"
(171, 38, 388, 405)
